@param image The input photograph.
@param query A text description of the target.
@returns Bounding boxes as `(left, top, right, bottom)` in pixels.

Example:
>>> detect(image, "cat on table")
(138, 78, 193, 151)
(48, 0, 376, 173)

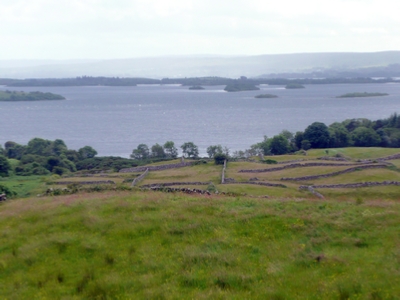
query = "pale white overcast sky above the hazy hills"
(0, 0, 400, 60)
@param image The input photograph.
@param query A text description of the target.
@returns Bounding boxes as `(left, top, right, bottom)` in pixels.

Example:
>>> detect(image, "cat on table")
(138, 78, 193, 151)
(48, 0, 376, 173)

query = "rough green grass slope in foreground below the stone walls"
(0, 192, 400, 299)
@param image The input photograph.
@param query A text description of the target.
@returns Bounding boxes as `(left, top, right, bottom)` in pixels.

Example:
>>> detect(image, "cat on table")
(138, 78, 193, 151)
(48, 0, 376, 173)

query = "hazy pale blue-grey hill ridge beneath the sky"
(0, 51, 400, 78)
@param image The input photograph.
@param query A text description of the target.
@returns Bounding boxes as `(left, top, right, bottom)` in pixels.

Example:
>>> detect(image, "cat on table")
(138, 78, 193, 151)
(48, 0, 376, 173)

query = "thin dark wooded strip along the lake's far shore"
(0, 76, 400, 87)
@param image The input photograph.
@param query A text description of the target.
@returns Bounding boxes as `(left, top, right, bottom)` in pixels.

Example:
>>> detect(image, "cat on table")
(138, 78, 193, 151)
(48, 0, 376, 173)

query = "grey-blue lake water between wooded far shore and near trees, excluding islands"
(0, 84, 400, 157)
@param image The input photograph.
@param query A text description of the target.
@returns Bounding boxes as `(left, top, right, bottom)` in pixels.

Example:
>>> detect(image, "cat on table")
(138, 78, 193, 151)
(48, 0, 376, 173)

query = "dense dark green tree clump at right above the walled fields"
(241, 113, 400, 157)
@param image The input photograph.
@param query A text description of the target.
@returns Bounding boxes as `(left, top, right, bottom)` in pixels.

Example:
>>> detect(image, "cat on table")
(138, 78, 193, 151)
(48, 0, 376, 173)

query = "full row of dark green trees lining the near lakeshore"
(0, 113, 400, 176)
